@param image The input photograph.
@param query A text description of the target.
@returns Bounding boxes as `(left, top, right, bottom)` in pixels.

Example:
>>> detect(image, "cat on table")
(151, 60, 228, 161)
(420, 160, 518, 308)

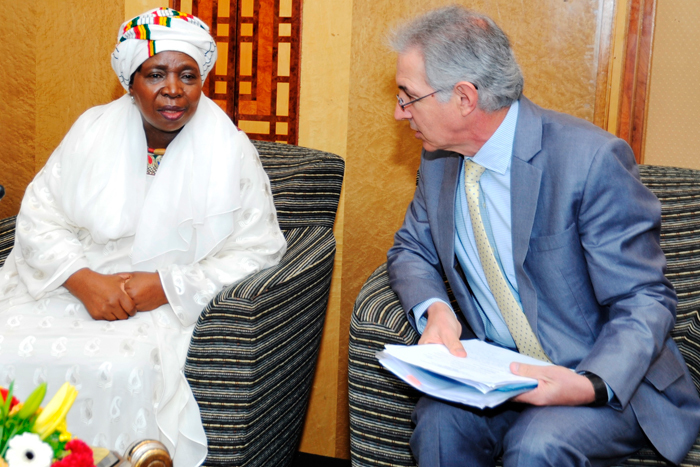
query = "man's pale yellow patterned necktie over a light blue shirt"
(464, 158, 549, 362)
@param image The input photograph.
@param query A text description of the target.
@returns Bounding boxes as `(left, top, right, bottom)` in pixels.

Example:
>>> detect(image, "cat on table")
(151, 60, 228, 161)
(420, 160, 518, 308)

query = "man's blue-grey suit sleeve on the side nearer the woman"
(387, 154, 450, 327)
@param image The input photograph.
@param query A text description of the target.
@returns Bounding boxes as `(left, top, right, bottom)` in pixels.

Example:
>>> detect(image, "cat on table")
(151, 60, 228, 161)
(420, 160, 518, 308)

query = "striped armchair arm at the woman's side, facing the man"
(185, 226, 335, 466)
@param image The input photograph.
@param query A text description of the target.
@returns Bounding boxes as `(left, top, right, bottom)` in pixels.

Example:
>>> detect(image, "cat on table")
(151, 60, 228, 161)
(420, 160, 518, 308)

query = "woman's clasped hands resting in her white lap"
(63, 268, 168, 321)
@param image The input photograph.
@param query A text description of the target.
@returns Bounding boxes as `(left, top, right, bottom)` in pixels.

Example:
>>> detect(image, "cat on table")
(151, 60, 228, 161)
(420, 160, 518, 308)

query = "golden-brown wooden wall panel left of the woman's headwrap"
(0, 0, 124, 218)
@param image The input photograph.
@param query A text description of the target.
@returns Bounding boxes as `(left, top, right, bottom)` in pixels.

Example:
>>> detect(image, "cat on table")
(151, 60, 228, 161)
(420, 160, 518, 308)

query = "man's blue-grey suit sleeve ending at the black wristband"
(577, 139, 676, 407)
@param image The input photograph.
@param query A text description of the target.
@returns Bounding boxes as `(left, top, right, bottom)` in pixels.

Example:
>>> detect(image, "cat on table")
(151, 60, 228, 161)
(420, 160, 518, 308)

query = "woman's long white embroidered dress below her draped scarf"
(0, 97, 286, 467)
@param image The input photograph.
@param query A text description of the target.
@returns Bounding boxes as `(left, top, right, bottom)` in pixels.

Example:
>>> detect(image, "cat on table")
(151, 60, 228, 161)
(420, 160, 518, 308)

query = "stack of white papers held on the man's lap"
(377, 339, 551, 409)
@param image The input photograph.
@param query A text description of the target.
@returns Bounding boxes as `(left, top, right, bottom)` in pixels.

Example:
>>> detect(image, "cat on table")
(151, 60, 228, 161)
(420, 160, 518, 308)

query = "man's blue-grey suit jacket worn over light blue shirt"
(388, 97, 700, 462)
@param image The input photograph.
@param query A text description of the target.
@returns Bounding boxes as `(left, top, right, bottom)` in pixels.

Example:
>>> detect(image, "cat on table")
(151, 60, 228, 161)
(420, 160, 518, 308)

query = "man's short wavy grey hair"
(389, 5, 523, 112)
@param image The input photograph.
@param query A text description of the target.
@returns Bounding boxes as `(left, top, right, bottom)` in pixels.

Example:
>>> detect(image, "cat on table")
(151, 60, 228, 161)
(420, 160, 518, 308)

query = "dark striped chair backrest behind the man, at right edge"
(639, 165, 700, 391)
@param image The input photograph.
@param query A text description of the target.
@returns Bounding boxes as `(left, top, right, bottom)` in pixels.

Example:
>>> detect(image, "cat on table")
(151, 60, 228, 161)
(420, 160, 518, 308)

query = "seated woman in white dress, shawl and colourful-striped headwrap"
(0, 8, 286, 467)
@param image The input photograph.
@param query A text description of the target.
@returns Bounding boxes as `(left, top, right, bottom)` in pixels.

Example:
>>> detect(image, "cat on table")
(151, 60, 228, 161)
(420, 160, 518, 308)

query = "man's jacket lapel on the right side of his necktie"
(510, 97, 542, 328)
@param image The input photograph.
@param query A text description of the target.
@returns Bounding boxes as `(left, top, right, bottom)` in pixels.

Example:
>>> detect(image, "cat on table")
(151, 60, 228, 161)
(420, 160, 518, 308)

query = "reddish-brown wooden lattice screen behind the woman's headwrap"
(171, 0, 301, 144)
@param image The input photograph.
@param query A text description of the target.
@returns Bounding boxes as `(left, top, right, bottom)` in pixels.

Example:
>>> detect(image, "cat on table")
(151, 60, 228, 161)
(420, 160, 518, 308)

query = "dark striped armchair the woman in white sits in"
(0, 141, 345, 467)
